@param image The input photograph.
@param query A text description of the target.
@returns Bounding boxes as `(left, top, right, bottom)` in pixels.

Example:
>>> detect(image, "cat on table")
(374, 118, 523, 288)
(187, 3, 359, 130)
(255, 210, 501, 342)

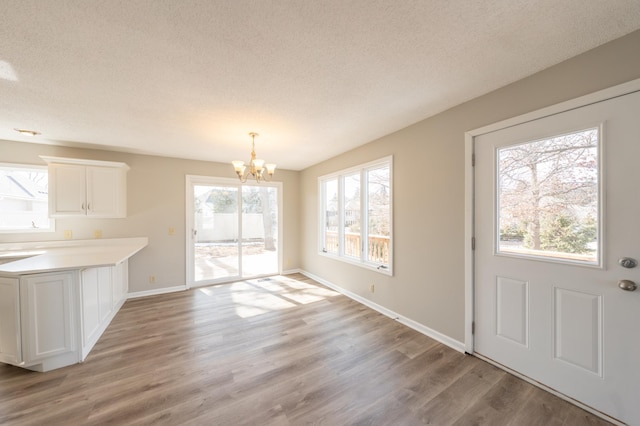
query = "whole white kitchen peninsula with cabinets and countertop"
(0, 237, 148, 371)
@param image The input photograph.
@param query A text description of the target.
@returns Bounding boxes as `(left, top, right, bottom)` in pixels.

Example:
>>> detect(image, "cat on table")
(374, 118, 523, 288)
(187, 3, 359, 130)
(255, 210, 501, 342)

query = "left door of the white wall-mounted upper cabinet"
(49, 164, 87, 217)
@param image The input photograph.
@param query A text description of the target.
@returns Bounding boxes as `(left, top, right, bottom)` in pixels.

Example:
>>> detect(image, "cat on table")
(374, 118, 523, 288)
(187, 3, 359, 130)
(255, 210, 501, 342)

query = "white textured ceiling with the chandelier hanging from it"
(0, 0, 640, 170)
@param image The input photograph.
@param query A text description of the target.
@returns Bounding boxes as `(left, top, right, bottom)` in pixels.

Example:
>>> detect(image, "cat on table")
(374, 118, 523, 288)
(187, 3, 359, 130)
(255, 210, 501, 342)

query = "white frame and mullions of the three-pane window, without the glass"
(318, 155, 393, 276)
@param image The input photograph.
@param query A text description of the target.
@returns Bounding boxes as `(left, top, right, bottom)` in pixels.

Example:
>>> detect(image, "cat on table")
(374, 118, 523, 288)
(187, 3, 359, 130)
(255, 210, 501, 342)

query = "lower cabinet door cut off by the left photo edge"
(0, 278, 22, 364)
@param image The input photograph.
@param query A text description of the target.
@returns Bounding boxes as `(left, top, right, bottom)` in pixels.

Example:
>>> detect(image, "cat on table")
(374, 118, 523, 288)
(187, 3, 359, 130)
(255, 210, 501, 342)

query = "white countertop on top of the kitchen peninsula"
(0, 237, 149, 275)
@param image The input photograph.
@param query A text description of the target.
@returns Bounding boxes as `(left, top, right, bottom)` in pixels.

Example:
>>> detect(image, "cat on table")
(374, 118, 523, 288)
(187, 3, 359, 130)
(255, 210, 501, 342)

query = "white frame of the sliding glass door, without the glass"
(185, 175, 284, 289)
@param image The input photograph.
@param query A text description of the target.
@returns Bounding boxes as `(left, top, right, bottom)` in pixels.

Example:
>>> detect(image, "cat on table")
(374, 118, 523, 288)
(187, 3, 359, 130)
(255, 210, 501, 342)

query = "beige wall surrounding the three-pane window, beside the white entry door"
(300, 31, 640, 342)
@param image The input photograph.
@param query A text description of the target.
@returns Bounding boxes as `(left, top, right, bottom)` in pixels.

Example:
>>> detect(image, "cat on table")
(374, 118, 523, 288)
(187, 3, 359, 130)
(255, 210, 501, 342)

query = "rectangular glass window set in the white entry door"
(496, 128, 601, 265)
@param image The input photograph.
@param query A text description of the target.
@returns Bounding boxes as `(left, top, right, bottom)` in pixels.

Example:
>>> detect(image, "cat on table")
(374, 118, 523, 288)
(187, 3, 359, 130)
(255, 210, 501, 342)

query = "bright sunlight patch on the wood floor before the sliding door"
(198, 276, 339, 318)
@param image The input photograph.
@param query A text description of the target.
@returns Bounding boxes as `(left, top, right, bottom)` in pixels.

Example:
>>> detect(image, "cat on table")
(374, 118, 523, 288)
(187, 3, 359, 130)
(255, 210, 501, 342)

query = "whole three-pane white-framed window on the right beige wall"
(318, 157, 393, 275)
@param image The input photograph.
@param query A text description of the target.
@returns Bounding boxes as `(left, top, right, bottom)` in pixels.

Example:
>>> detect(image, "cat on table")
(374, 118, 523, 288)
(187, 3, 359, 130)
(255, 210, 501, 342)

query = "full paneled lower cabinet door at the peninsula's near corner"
(21, 272, 75, 363)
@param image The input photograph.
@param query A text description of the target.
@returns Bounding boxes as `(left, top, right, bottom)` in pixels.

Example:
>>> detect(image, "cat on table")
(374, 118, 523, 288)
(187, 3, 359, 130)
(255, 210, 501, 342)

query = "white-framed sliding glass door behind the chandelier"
(187, 176, 281, 286)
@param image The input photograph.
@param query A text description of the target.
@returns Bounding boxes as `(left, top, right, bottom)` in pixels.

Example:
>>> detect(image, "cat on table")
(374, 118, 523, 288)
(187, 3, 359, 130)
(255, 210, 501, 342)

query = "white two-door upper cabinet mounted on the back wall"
(41, 156, 129, 218)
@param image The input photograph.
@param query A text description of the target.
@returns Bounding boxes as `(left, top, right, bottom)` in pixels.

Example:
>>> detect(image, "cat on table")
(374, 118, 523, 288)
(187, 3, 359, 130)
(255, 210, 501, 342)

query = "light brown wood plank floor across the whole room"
(0, 275, 607, 425)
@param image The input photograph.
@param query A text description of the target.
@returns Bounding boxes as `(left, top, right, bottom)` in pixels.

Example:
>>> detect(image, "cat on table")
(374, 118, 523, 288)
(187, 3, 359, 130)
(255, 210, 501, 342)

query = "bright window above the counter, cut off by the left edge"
(0, 164, 55, 233)
